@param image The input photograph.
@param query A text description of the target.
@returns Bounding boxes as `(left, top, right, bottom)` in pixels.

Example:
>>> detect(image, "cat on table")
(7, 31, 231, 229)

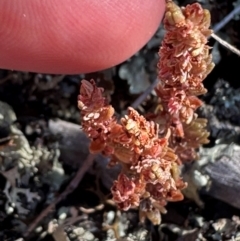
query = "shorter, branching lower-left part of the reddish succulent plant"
(78, 80, 186, 224)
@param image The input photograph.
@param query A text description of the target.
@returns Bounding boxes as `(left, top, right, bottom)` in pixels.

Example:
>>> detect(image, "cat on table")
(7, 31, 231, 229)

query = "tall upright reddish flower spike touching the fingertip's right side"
(156, 1, 214, 161)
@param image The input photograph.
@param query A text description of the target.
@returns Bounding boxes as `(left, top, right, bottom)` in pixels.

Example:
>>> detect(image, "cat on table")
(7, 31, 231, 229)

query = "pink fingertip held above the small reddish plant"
(0, 0, 165, 74)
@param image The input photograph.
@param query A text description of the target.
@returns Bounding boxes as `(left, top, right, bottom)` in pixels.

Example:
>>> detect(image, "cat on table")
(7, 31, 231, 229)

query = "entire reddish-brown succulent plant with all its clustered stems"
(78, 1, 214, 224)
